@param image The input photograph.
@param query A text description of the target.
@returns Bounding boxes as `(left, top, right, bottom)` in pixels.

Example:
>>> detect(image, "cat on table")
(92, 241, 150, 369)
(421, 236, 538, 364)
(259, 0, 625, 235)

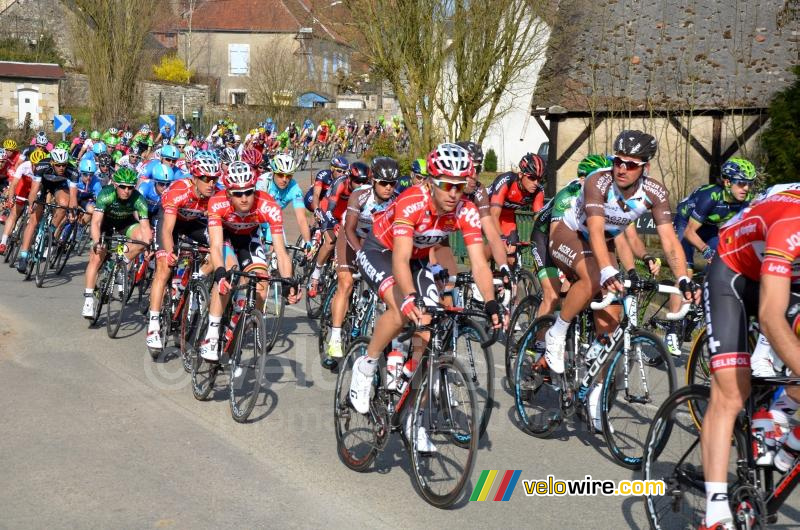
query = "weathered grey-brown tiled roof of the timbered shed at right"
(533, 0, 800, 111)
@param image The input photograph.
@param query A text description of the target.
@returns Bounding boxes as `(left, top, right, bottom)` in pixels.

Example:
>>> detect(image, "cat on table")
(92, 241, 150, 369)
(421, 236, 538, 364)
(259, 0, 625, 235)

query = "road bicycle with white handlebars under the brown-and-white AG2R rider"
(514, 279, 689, 469)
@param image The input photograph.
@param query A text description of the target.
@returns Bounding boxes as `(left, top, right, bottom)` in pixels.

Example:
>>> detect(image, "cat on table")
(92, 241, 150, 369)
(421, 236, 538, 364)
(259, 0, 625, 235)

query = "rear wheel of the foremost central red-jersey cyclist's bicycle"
(333, 337, 378, 472)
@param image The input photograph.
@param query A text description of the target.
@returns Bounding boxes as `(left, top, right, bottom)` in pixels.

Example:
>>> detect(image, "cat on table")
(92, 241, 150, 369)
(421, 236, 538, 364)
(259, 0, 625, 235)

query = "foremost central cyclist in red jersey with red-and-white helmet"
(350, 144, 500, 451)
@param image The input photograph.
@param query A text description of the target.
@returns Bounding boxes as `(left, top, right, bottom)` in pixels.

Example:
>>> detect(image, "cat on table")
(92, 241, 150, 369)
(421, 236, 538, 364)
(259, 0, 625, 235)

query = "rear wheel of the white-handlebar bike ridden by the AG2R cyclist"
(513, 315, 570, 438)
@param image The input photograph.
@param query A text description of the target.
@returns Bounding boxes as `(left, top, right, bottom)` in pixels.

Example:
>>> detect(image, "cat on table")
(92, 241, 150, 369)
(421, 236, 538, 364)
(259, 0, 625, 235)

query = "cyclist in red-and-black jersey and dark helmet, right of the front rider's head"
(489, 153, 544, 256)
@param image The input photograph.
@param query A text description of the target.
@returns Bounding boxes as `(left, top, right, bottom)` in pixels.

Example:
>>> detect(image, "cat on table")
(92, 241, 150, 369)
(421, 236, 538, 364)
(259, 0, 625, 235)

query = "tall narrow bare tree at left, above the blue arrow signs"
(62, 0, 160, 125)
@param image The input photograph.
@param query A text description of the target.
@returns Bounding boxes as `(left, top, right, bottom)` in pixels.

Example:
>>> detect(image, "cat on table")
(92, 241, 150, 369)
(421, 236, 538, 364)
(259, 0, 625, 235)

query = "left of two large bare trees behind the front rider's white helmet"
(344, 0, 452, 153)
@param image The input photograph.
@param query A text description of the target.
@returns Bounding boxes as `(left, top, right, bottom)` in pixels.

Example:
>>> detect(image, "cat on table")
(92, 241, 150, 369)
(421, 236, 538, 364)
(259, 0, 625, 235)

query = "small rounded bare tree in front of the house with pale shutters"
(248, 42, 309, 111)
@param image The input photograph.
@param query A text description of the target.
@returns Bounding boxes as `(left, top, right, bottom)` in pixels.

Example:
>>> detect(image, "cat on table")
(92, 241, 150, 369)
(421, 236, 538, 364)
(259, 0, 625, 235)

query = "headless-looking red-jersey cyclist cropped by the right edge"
(700, 184, 800, 530)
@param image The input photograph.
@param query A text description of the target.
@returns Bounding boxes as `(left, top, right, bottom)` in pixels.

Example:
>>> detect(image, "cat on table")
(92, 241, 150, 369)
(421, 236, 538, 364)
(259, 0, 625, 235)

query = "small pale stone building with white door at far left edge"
(0, 61, 64, 127)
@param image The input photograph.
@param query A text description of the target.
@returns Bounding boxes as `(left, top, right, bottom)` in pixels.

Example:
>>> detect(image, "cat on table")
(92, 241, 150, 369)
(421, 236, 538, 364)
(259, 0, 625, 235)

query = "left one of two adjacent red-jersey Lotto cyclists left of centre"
(145, 151, 222, 352)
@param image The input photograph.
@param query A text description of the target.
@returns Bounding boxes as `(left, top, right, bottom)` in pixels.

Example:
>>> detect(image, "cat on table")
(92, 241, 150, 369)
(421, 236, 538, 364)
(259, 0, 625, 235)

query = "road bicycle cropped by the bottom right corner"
(643, 376, 800, 528)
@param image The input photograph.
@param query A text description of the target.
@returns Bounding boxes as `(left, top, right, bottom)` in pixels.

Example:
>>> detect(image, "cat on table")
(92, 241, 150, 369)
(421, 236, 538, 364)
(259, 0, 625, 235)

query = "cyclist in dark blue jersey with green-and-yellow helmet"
(664, 158, 756, 356)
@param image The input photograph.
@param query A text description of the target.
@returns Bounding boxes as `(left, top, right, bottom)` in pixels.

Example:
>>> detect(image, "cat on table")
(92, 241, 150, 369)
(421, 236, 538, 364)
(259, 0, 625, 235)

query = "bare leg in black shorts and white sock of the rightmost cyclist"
(700, 260, 758, 526)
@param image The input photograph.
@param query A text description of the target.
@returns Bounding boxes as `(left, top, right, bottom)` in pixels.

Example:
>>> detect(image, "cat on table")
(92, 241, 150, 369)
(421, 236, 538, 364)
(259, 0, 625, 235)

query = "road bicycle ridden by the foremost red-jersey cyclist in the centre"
(334, 307, 478, 508)
